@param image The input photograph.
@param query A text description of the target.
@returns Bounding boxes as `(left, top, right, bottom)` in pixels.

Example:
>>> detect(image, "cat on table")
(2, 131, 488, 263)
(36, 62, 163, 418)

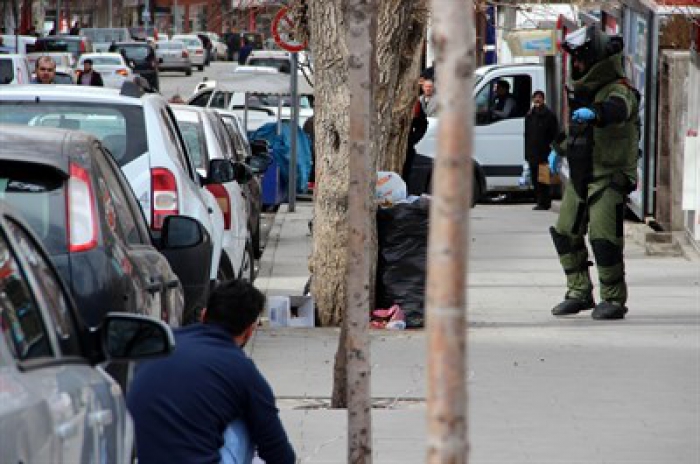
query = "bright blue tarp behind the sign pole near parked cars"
(248, 121, 311, 193)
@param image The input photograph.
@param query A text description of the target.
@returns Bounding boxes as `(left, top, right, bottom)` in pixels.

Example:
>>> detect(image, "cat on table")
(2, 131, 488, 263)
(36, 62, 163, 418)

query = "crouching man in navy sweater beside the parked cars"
(127, 280, 295, 464)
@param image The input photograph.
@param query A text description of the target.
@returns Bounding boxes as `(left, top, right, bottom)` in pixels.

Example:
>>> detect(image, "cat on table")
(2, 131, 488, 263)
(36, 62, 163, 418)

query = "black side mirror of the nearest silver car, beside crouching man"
(100, 313, 175, 361)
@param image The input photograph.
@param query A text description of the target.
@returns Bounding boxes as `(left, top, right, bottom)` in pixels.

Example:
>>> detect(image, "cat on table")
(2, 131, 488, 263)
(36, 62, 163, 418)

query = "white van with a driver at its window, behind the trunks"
(416, 64, 547, 196)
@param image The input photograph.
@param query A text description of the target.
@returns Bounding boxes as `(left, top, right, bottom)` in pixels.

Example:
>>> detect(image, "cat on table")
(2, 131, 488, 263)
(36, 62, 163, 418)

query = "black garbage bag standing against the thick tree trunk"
(377, 198, 430, 328)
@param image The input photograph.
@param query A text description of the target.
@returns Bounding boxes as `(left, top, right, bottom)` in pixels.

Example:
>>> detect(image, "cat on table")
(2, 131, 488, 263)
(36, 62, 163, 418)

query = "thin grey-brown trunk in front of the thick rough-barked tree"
(343, 0, 377, 458)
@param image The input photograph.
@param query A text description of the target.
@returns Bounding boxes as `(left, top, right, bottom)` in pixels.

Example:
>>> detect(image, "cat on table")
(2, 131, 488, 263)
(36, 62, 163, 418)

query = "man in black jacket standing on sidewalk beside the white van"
(525, 90, 559, 211)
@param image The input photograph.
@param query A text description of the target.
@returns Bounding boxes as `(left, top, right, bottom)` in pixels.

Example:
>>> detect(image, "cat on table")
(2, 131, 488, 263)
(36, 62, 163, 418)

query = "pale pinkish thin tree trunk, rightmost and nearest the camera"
(427, 0, 474, 464)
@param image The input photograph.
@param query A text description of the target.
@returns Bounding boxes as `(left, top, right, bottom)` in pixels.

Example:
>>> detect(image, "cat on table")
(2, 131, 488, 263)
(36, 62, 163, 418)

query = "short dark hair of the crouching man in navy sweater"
(204, 279, 265, 336)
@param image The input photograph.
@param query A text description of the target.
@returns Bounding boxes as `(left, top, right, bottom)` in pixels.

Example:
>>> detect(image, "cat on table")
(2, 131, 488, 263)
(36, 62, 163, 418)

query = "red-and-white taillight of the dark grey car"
(66, 163, 97, 253)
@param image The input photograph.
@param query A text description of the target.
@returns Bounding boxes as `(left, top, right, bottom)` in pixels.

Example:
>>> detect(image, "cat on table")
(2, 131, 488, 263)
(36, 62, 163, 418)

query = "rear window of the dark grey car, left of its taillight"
(0, 161, 68, 254)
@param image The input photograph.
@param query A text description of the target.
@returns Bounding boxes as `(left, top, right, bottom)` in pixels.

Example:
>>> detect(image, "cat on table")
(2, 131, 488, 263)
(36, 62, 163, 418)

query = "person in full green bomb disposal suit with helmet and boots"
(549, 26, 639, 319)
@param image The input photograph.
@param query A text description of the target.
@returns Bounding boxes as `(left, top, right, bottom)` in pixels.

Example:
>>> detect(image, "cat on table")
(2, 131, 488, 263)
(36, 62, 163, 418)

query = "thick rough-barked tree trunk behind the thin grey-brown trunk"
(308, 0, 427, 326)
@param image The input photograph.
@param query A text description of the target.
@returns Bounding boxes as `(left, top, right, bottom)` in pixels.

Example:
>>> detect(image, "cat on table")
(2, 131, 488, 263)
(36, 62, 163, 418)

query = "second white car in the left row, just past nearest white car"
(173, 105, 255, 282)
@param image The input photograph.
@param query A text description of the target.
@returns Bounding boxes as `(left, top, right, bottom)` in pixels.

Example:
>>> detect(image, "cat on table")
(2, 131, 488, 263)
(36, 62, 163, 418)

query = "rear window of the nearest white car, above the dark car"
(0, 99, 148, 167)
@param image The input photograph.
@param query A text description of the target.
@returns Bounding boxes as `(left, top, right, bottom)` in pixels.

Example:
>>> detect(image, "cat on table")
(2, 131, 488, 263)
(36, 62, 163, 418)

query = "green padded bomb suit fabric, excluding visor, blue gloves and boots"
(550, 54, 639, 306)
